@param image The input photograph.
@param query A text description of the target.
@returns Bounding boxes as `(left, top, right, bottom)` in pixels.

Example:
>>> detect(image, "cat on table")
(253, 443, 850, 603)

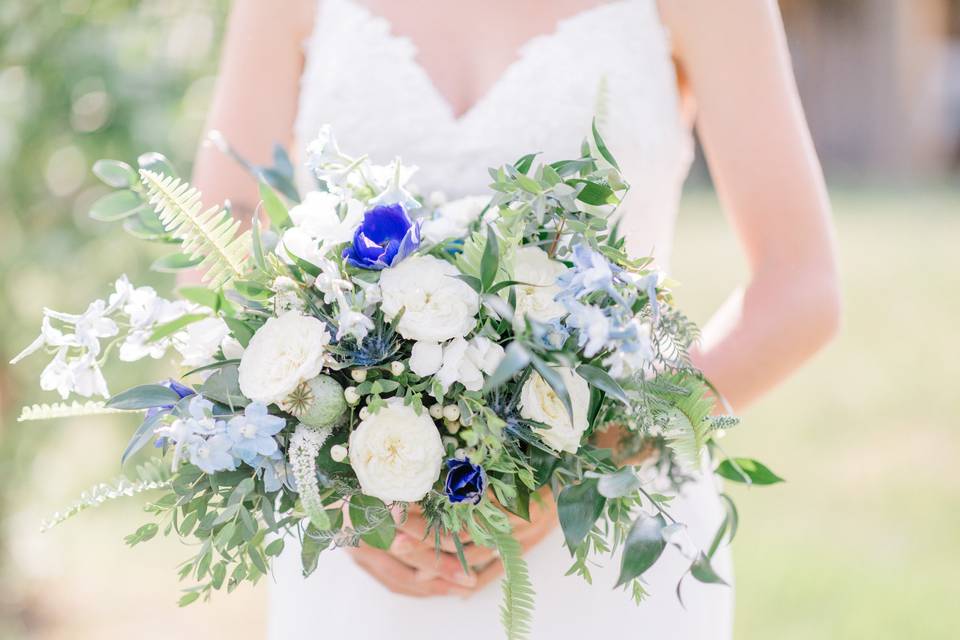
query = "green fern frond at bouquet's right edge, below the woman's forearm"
(663, 376, 713, 469)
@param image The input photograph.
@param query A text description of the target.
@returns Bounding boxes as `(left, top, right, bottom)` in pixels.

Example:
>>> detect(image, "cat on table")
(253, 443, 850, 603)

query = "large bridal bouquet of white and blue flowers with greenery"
(14, 126, 779, 637)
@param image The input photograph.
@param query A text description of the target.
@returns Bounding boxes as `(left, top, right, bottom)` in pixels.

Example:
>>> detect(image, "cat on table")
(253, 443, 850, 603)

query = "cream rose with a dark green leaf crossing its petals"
(520, 367, 590, 453)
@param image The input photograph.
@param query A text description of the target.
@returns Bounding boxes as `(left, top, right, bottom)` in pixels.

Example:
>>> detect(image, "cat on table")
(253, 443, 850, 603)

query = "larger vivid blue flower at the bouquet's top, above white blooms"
(343, 204, 420, 270)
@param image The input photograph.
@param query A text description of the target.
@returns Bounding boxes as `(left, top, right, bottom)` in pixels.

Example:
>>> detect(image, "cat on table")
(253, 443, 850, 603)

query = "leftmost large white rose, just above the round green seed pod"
(239, 311, 330, 404)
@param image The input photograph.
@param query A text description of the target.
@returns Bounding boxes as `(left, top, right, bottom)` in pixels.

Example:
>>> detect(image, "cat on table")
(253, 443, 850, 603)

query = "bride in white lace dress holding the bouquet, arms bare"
(194, 0, 839, 640)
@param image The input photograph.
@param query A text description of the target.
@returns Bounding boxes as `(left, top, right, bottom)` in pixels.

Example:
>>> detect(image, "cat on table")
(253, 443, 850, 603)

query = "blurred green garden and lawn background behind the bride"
(0, 0, 960, 640)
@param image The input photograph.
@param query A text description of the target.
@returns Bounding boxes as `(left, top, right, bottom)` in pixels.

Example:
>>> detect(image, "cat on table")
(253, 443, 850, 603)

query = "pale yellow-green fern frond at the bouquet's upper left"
(140, 169, 250, 289)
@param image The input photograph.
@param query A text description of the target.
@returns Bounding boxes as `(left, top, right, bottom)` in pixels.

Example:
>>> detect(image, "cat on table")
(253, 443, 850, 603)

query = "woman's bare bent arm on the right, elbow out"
(661, 0, 840, 409)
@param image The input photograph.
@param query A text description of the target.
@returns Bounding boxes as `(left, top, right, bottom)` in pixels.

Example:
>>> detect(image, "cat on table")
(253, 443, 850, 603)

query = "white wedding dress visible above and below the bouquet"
(269, 0, 733, 640)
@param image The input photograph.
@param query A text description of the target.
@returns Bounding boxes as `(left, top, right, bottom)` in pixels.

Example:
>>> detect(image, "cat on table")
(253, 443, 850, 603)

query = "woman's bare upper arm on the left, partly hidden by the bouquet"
(193, 0, 313, 216)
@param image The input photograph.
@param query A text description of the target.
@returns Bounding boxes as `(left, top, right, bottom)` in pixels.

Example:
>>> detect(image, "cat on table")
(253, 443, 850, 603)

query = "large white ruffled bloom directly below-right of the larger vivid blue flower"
(380, 256, 480, 342)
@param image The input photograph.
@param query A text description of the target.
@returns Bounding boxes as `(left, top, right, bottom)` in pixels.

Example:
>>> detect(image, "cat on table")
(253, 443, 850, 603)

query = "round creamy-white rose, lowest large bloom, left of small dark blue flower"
(349, 398, 443, 502)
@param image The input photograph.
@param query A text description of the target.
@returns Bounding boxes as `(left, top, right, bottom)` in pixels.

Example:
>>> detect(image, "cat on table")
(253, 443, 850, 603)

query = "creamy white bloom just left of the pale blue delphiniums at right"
(513, 246, 566, 325)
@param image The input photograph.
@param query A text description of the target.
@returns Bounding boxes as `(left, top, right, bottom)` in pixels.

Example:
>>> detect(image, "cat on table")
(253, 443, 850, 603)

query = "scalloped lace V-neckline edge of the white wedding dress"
(343, 0, 631, 126)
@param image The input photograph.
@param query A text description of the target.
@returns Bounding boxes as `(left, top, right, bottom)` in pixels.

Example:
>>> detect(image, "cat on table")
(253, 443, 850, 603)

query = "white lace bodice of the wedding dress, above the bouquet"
(295, 0, 692, 264)
